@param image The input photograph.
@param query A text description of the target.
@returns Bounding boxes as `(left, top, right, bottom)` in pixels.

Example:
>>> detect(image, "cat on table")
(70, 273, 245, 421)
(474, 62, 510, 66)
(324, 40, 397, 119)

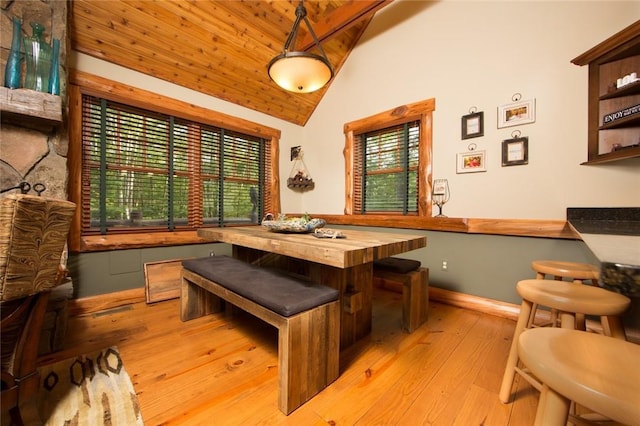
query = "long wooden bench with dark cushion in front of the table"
(180, 256, 340, 415)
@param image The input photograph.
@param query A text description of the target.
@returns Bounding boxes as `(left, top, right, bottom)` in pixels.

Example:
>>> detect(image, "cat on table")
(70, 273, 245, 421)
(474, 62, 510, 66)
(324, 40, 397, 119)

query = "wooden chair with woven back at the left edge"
(0, 194, 75, 425)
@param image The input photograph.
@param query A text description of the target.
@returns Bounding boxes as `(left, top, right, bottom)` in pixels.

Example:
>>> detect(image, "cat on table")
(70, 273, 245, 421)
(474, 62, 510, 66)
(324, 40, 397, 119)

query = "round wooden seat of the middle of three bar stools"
(516, 280, 631, 316)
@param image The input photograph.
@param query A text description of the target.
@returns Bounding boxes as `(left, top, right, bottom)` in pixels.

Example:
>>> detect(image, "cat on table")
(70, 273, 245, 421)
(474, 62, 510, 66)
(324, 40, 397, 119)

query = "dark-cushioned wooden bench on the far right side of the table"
(373, 257, 429, 333)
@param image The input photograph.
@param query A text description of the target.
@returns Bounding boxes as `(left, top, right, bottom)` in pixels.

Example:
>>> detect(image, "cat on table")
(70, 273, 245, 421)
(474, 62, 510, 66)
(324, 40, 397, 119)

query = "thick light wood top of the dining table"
(198, 226, 427, 268)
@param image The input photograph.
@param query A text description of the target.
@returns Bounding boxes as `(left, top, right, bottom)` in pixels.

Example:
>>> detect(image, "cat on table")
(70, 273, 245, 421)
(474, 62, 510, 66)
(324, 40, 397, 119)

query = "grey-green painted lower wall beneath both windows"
(69, 226, 598, 303)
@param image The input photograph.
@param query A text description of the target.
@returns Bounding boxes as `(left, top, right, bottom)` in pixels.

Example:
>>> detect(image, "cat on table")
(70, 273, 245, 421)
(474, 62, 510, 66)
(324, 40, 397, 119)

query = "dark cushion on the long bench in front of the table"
(182, 256, 338, 317)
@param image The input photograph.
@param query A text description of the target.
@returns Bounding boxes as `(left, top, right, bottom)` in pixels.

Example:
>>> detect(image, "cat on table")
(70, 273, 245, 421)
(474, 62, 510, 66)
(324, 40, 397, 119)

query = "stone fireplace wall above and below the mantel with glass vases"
(0, 0, 69, 199)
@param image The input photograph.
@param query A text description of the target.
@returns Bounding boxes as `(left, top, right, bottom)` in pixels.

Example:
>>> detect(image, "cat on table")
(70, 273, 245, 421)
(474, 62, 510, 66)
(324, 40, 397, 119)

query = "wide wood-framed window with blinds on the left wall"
(69, 72, 280, 251)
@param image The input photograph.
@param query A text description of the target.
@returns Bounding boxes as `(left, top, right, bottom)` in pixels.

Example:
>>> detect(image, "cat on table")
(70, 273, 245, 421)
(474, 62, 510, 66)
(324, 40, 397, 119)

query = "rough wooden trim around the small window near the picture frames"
(343, 98, 436, 217)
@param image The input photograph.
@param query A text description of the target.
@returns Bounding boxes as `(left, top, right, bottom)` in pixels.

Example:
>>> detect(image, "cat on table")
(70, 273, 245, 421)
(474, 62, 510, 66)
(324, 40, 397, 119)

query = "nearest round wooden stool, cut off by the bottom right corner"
(518, 328, 640, 425)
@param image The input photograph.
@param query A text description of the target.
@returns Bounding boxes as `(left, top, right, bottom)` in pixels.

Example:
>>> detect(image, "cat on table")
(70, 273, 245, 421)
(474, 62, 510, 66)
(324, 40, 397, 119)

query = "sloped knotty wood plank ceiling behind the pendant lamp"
(70, 0, 392, 125)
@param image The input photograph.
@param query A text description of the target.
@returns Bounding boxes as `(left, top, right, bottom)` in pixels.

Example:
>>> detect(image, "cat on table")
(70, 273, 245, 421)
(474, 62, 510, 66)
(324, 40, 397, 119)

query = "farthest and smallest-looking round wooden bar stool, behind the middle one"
(527, 260, 600, 330)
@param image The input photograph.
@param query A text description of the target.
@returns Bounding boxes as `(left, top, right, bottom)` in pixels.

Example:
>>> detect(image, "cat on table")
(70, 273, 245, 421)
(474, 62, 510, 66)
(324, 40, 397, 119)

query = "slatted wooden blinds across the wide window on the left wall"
(82, 95, 270, 234)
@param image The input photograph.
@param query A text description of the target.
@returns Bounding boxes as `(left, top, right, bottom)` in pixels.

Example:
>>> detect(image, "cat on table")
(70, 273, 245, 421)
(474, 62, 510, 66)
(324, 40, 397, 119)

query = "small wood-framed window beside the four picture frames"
(344, 100, 435, 216)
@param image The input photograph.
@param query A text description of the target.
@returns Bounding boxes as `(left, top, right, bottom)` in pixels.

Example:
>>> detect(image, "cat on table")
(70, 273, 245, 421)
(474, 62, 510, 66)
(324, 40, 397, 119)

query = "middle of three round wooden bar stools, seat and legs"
(499, 280, 631, 404)
